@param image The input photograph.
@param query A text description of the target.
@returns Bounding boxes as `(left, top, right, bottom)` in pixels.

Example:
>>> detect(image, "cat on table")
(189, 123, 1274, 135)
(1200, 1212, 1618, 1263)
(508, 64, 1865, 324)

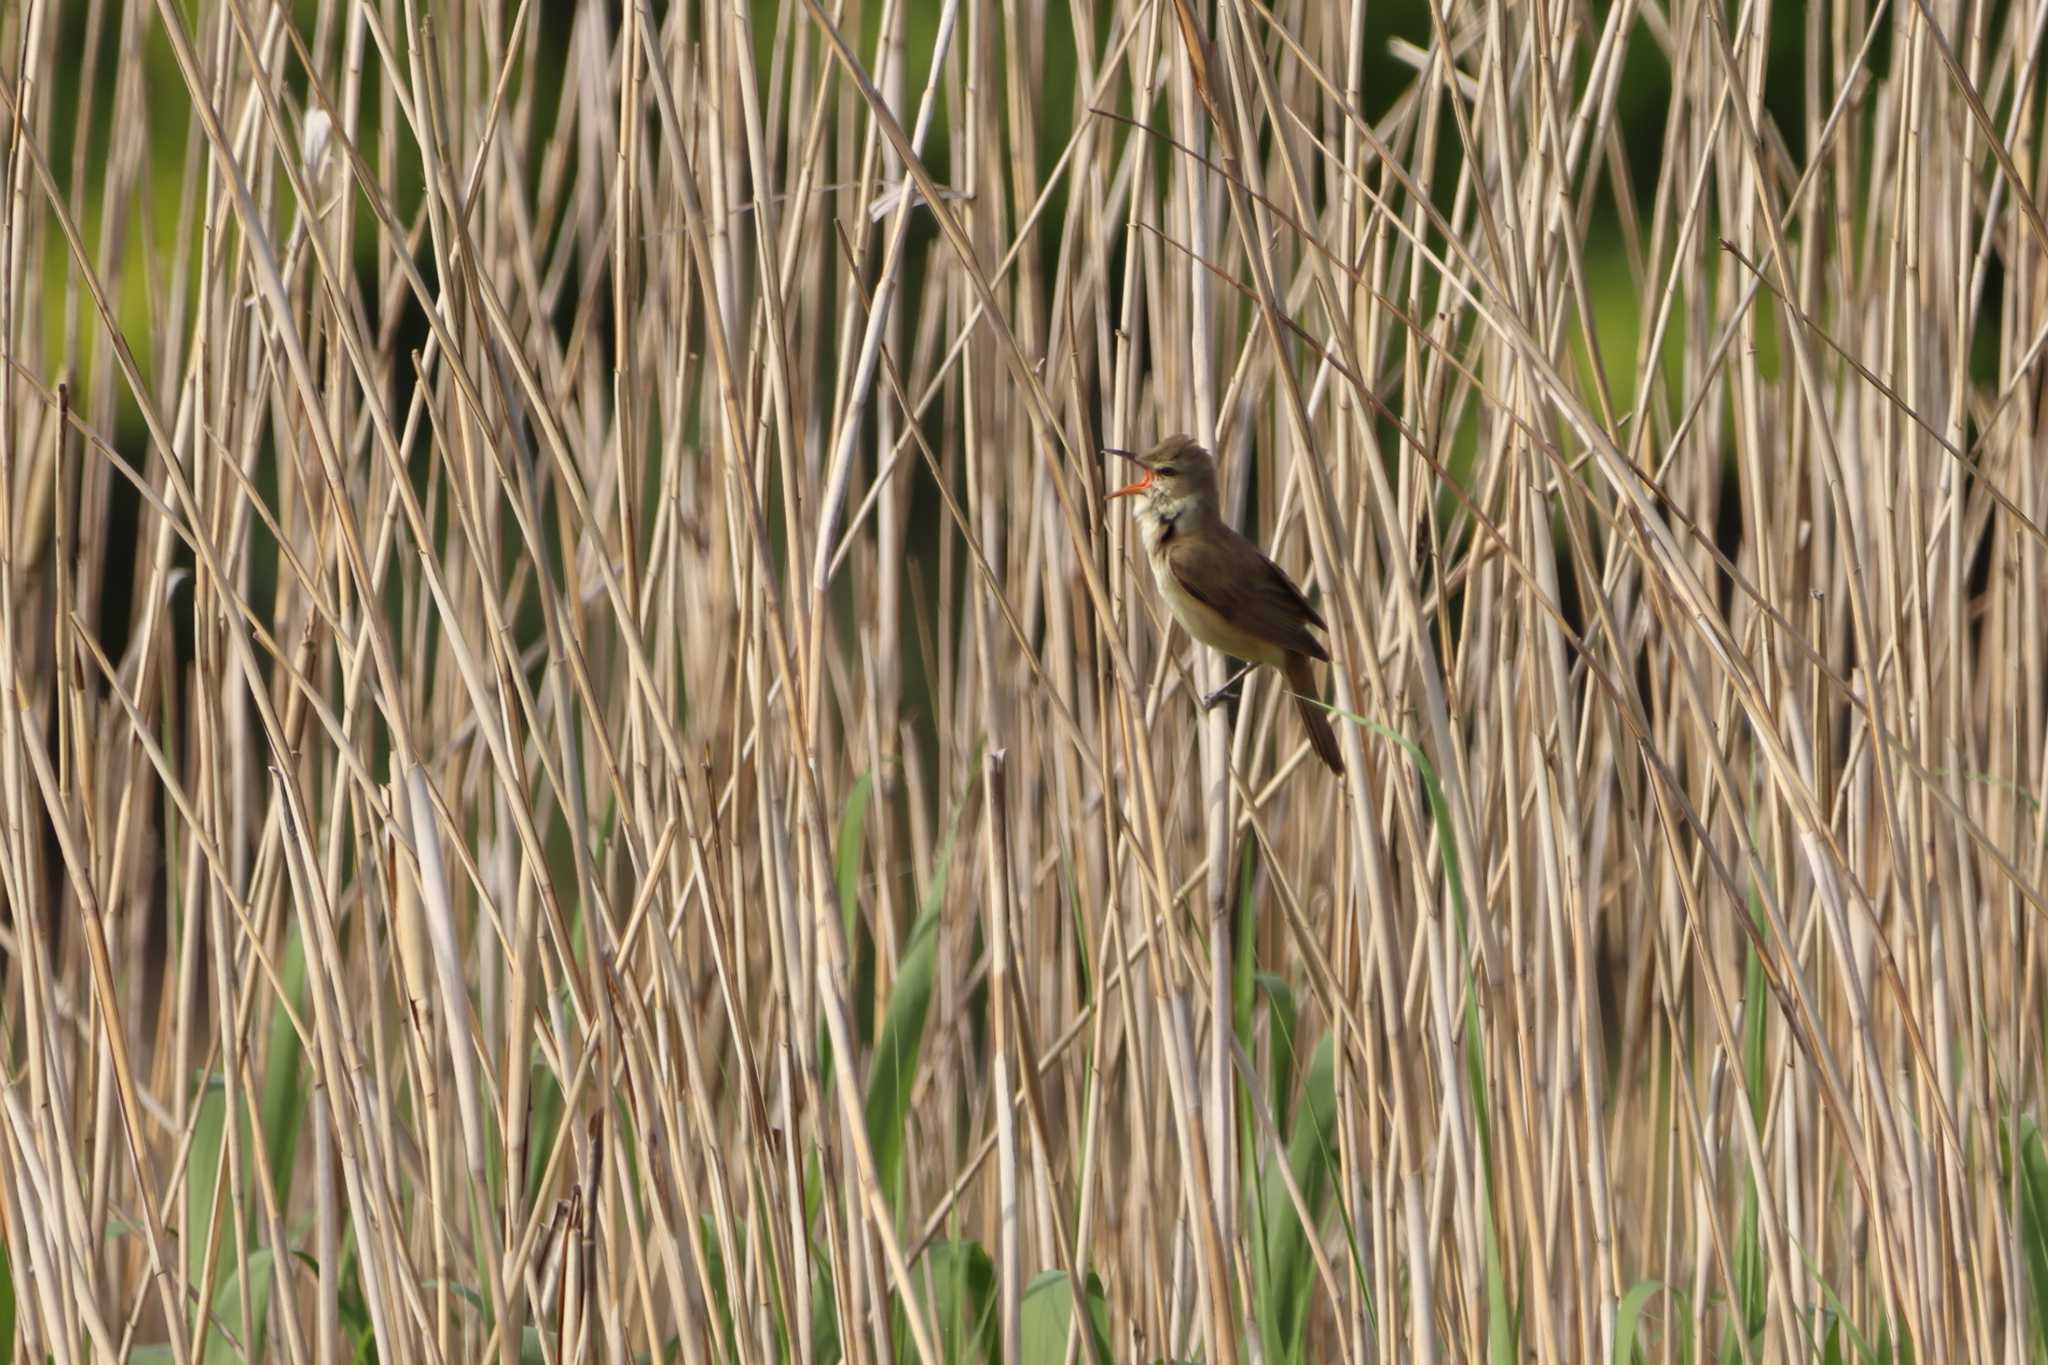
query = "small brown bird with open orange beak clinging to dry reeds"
(1104, 436, 1343, 776)
